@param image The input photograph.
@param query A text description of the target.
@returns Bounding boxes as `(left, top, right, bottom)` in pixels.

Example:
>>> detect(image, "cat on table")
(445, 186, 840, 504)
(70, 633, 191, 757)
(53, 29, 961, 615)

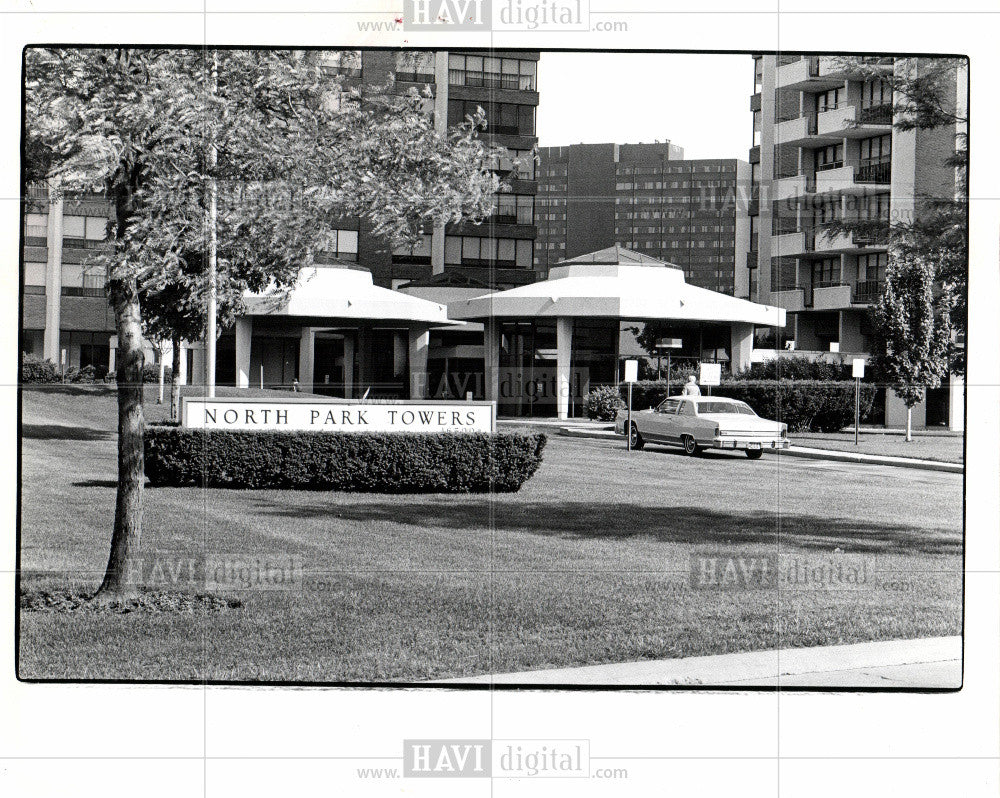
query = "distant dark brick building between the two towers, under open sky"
(535, 142, 750, 297)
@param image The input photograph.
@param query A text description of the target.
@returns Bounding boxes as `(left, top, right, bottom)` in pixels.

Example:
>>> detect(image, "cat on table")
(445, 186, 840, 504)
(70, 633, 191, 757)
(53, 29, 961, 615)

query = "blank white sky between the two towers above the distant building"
(537, 52, 753, 161)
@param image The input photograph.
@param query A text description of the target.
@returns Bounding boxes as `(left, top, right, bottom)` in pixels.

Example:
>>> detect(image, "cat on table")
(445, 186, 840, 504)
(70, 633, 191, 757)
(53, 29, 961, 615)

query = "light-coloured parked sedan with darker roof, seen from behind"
(615, 396, 788, 460)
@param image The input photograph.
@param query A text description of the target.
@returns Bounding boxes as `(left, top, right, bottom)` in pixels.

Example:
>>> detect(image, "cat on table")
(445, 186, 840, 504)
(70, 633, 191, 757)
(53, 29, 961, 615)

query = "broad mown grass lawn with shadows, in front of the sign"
(19, 387, 962, 681)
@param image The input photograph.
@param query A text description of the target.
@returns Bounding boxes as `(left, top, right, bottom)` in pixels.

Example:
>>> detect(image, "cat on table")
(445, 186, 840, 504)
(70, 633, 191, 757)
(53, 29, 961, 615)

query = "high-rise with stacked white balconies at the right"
(745, 55, 962, 427)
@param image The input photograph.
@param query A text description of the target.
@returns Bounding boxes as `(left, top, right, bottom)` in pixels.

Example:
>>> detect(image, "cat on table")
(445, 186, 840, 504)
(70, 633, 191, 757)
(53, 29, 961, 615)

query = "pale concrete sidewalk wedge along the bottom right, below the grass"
(436, 637, 962, 689)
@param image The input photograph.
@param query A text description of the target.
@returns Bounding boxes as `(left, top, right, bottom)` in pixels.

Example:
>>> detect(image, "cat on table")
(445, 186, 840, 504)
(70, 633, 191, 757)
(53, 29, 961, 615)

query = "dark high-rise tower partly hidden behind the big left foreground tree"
(22, 50, 538, 385)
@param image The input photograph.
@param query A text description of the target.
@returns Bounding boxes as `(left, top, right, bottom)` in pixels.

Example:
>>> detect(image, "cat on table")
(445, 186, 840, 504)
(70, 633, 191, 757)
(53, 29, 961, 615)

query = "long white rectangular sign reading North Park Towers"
(181, 396, 496, 432)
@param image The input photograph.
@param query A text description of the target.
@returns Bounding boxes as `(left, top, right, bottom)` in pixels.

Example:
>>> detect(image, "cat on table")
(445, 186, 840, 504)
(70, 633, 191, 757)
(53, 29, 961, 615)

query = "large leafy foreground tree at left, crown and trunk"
(25, 48, 508, 603)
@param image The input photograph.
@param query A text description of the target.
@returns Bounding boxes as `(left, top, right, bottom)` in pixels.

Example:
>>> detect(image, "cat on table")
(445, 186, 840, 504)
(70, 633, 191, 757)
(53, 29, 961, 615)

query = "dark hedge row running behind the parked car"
(621, 380, 876, 432)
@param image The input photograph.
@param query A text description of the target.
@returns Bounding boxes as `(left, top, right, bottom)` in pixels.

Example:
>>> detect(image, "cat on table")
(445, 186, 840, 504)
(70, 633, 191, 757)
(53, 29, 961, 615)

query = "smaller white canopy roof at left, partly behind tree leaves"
(245, 266, 455, 325)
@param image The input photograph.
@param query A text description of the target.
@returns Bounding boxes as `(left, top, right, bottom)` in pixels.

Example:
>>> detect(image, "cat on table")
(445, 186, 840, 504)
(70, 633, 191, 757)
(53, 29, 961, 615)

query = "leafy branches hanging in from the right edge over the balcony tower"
(823, 57, 969, 374)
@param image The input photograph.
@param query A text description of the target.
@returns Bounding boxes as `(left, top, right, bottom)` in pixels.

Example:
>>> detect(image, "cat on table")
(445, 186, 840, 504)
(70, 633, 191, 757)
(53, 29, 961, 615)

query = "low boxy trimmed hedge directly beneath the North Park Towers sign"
(145, 425, 546, 493)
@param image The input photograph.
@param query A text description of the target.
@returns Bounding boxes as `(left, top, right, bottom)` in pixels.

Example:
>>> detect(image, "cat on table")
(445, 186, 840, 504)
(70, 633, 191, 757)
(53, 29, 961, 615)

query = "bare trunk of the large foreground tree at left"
(95, 278, 145, 602)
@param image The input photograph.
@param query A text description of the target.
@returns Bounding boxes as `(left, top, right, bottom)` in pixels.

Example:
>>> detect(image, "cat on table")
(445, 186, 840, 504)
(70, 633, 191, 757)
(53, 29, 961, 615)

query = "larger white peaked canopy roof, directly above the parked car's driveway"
(448, 247, 785, 327)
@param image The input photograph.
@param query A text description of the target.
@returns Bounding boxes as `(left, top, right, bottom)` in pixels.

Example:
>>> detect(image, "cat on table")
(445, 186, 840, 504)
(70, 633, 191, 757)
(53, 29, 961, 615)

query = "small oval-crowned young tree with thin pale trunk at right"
(872, 245, 951, 441)
